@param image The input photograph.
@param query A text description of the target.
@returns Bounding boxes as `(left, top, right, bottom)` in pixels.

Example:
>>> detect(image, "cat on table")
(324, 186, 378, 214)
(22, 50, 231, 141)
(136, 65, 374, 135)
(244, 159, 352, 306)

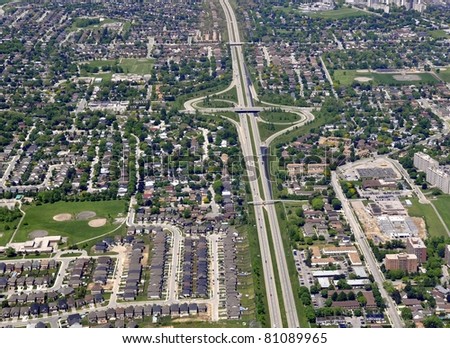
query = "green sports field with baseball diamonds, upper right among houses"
(333, 70, 438, 87)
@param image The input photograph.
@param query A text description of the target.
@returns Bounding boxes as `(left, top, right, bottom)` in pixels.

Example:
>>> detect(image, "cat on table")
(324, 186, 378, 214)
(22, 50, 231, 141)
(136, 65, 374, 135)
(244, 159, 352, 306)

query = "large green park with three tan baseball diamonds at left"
(14, 200, 127, 245)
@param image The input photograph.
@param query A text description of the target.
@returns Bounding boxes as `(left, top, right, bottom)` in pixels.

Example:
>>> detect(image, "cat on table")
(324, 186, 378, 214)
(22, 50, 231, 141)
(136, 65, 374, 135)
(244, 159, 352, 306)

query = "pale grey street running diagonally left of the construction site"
(331, 172, 403, 328)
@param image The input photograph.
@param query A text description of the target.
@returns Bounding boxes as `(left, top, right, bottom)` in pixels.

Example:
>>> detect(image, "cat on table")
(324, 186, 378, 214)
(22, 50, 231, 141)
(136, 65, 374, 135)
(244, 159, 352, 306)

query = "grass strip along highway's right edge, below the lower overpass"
(275, 202, 310, 327)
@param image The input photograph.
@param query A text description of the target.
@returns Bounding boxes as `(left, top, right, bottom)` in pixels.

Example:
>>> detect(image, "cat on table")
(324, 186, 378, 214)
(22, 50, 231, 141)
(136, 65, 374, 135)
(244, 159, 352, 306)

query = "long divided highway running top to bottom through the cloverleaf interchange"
(220, 0, 299, 327)
